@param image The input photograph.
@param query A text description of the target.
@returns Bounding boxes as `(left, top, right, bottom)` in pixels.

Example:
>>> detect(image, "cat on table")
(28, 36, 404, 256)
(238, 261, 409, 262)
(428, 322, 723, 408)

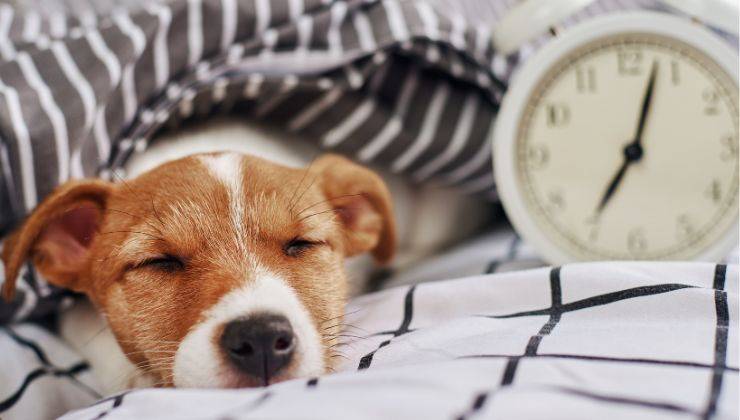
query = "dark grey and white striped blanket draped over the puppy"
(0, 0, 655, 323)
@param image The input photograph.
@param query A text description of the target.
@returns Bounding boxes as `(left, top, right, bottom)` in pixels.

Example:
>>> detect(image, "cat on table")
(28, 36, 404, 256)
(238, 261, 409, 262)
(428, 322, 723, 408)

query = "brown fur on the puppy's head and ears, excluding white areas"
(2, 155, 396, 386)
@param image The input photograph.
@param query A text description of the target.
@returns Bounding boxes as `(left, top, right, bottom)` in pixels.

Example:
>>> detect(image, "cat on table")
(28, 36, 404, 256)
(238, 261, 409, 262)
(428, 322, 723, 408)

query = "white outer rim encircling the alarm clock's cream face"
(492, 11, 740, 264)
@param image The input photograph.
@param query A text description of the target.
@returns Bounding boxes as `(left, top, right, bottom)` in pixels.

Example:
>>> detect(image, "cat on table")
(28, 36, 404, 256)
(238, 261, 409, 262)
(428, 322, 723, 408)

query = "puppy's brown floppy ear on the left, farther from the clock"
(2, 180, 113, 301)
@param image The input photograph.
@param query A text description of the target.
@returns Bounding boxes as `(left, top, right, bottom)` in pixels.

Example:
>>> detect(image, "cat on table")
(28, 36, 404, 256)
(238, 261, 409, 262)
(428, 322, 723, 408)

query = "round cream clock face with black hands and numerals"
(514, 33, 738, 259)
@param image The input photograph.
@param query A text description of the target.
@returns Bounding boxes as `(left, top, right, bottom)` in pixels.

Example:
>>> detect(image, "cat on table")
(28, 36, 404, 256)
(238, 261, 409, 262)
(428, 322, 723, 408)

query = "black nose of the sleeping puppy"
(221, 314, 296, 385)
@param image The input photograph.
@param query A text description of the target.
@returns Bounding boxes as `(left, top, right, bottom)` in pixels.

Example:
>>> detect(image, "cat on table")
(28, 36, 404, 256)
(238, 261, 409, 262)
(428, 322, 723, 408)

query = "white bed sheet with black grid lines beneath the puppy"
(0, 230, 740, 420)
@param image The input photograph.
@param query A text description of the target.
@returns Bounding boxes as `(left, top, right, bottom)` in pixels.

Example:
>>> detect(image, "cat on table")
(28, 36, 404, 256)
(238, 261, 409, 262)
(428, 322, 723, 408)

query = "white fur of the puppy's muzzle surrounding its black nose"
(172, 274, 325, 388)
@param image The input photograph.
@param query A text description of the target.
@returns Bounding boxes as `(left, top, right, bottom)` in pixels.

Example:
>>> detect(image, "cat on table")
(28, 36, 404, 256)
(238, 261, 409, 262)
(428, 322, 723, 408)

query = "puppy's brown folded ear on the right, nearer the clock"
(313, 154, 396, 264)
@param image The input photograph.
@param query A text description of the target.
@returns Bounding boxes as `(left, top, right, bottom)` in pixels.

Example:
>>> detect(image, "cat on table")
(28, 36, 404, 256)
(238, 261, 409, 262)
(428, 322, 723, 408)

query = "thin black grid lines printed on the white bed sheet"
(0, 264, 739, 419)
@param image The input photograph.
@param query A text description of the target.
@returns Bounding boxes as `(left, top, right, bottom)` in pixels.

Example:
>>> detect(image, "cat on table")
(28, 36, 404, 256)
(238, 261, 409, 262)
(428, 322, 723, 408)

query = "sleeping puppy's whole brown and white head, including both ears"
(3, 153, 395, 387)
